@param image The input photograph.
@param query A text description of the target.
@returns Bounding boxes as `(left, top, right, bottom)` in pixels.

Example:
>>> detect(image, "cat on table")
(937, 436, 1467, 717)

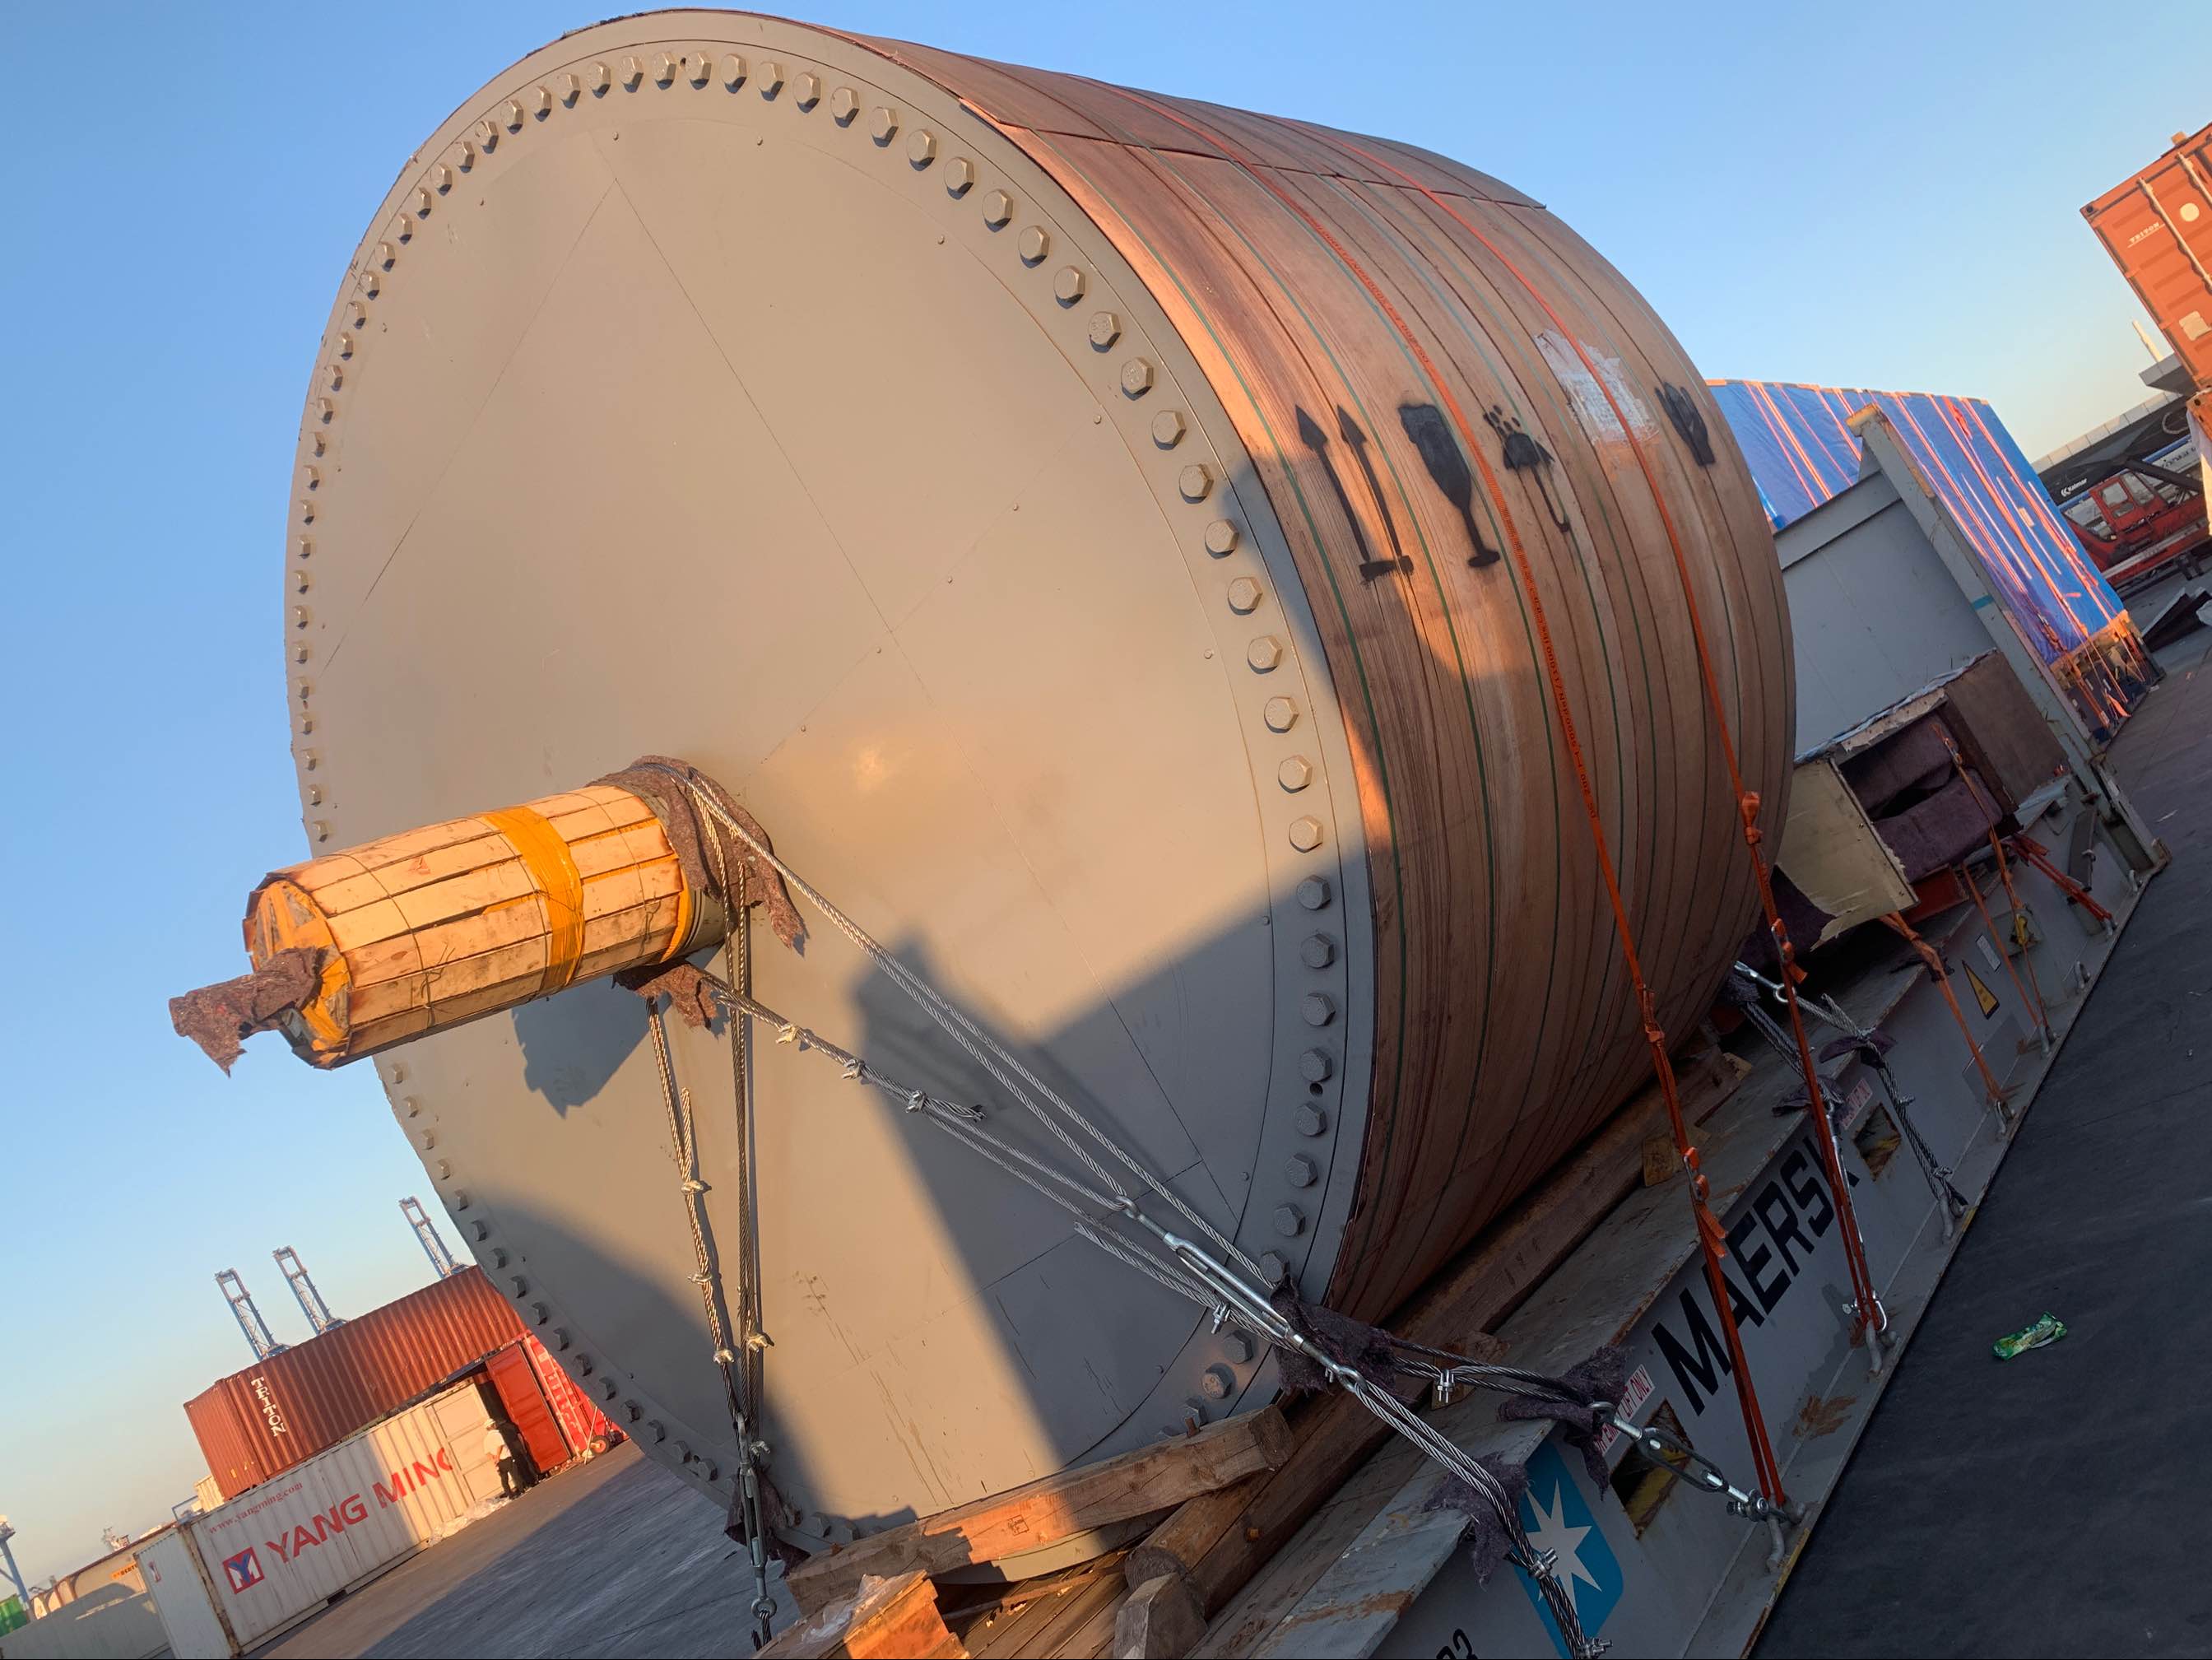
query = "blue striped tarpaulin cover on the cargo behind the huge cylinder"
(1712, 381, 2126, 662)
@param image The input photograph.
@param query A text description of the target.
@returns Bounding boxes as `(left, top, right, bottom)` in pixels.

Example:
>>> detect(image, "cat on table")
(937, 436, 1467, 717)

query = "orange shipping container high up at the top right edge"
(2081, 126, 2212, 388)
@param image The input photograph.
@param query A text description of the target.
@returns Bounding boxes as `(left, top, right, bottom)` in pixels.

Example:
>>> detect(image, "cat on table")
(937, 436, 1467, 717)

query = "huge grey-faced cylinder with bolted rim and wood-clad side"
(283, 11, 1791, 1538)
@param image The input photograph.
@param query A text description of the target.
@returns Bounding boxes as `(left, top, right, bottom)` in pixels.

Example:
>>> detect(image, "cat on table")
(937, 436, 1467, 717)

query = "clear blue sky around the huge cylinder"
(0, 0, 2212, 1578)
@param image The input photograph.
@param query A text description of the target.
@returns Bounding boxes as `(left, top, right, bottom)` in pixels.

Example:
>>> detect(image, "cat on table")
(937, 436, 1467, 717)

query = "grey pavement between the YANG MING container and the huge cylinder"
(258, 1445, 752, 1660)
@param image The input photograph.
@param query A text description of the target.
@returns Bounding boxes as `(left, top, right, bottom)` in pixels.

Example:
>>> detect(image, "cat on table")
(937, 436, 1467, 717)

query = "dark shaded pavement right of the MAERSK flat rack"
(1759, 609, 2212, 1660)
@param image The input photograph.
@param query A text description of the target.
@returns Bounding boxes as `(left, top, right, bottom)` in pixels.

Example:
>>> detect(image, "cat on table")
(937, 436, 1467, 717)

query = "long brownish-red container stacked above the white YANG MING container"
(184, 1266, 522, 1499)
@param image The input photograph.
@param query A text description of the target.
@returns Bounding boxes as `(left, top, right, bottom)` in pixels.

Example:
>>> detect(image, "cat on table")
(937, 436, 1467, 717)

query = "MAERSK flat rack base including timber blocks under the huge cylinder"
(778, 761, 2150, 1660)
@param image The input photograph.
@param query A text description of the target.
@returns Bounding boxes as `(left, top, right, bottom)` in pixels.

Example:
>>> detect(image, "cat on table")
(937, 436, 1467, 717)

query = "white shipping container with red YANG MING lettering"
(139, 1383, 500, 1660)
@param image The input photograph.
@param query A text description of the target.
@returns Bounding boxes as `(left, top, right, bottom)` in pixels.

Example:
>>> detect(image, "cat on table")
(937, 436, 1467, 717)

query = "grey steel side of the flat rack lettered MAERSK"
(1229, 808, 2144, 1656)
